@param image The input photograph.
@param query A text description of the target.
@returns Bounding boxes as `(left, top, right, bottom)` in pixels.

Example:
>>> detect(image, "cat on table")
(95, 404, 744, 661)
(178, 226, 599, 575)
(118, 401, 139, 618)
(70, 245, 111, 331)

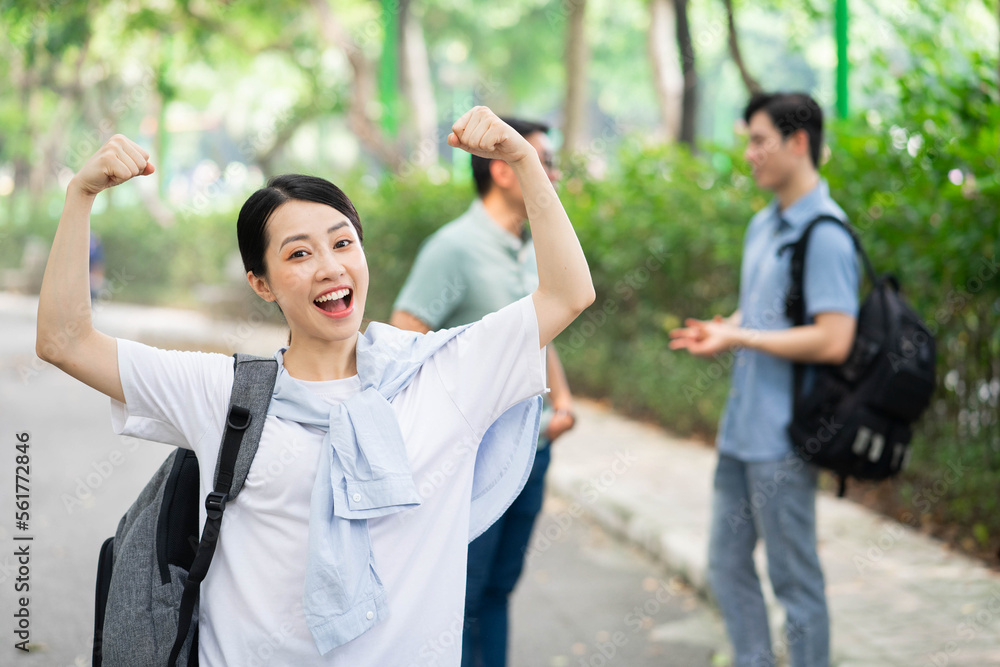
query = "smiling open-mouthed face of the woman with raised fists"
(254, 199, 368, 342)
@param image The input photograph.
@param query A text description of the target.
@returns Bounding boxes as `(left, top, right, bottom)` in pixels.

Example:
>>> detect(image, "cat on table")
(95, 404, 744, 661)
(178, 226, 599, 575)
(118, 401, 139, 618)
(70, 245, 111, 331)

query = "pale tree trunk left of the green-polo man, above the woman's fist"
(399, 0, 439, 167)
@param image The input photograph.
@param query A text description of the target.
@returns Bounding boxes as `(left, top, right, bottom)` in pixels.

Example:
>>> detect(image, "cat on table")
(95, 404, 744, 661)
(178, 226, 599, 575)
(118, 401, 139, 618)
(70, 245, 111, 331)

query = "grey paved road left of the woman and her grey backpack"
(0, 295, 177, 667)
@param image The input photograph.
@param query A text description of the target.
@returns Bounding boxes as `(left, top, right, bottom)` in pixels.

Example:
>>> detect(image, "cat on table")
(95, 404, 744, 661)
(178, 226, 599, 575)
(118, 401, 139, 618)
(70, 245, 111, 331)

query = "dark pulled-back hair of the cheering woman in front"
(236, 174, 364, 277)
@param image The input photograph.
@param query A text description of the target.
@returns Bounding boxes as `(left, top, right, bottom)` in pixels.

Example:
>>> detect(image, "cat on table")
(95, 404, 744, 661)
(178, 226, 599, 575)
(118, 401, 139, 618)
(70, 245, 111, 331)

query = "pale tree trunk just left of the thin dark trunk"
(649, 0, 684, 141)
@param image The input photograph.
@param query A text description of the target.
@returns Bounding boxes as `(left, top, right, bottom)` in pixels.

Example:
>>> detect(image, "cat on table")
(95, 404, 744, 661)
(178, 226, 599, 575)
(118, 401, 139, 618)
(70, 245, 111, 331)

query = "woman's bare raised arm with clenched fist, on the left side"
(35, 135, 154, 402)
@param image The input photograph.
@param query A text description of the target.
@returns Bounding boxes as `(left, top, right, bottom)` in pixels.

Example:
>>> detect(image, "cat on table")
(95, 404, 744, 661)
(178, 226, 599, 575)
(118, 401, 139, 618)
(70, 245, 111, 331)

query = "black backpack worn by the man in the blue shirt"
(779, 215, 935, 496)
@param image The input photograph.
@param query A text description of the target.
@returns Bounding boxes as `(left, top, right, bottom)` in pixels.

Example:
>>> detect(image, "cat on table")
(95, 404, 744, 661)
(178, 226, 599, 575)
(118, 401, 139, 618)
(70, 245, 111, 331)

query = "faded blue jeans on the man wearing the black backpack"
(708, 454, 830, 667)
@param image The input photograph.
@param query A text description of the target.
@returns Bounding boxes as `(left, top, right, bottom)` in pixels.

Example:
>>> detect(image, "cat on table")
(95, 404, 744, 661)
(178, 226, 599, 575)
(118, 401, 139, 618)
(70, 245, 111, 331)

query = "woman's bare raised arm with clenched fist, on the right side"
(448, 107, 594, 347)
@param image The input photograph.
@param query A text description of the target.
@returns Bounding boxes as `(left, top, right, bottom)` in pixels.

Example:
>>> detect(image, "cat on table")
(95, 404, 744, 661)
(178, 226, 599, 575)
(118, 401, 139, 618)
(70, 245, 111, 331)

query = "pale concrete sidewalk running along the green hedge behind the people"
(9, 293, 1000, 667)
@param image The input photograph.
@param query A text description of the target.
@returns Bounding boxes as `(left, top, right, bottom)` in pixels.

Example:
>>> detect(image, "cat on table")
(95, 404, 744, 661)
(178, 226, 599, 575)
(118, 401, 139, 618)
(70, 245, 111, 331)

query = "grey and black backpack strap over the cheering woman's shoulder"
(167, 354, 278, 667)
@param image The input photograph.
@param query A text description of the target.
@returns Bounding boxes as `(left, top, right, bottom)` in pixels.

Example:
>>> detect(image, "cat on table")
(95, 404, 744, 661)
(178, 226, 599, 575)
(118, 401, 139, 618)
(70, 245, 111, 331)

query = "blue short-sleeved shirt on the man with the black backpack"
(717, 180, 858, 461)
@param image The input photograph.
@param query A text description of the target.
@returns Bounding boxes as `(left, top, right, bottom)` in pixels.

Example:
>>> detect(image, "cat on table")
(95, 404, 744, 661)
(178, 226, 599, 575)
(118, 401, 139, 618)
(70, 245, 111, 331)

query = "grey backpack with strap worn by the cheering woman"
(94, 354, 278, 667)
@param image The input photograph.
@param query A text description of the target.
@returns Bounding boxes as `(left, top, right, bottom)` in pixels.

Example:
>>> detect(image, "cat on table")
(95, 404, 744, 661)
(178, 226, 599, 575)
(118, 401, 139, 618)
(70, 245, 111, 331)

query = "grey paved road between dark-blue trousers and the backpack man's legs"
(508, 495, 727, 667)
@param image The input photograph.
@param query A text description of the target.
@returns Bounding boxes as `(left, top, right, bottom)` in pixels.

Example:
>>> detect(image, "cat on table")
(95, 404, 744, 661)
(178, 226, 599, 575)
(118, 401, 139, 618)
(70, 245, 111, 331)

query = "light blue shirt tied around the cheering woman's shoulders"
(268, 323, 542, 655)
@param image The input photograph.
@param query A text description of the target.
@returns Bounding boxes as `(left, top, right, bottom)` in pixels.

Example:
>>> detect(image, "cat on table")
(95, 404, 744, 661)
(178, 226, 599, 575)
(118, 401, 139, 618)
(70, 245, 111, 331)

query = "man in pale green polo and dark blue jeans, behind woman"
(391, 118, 574, 667)
